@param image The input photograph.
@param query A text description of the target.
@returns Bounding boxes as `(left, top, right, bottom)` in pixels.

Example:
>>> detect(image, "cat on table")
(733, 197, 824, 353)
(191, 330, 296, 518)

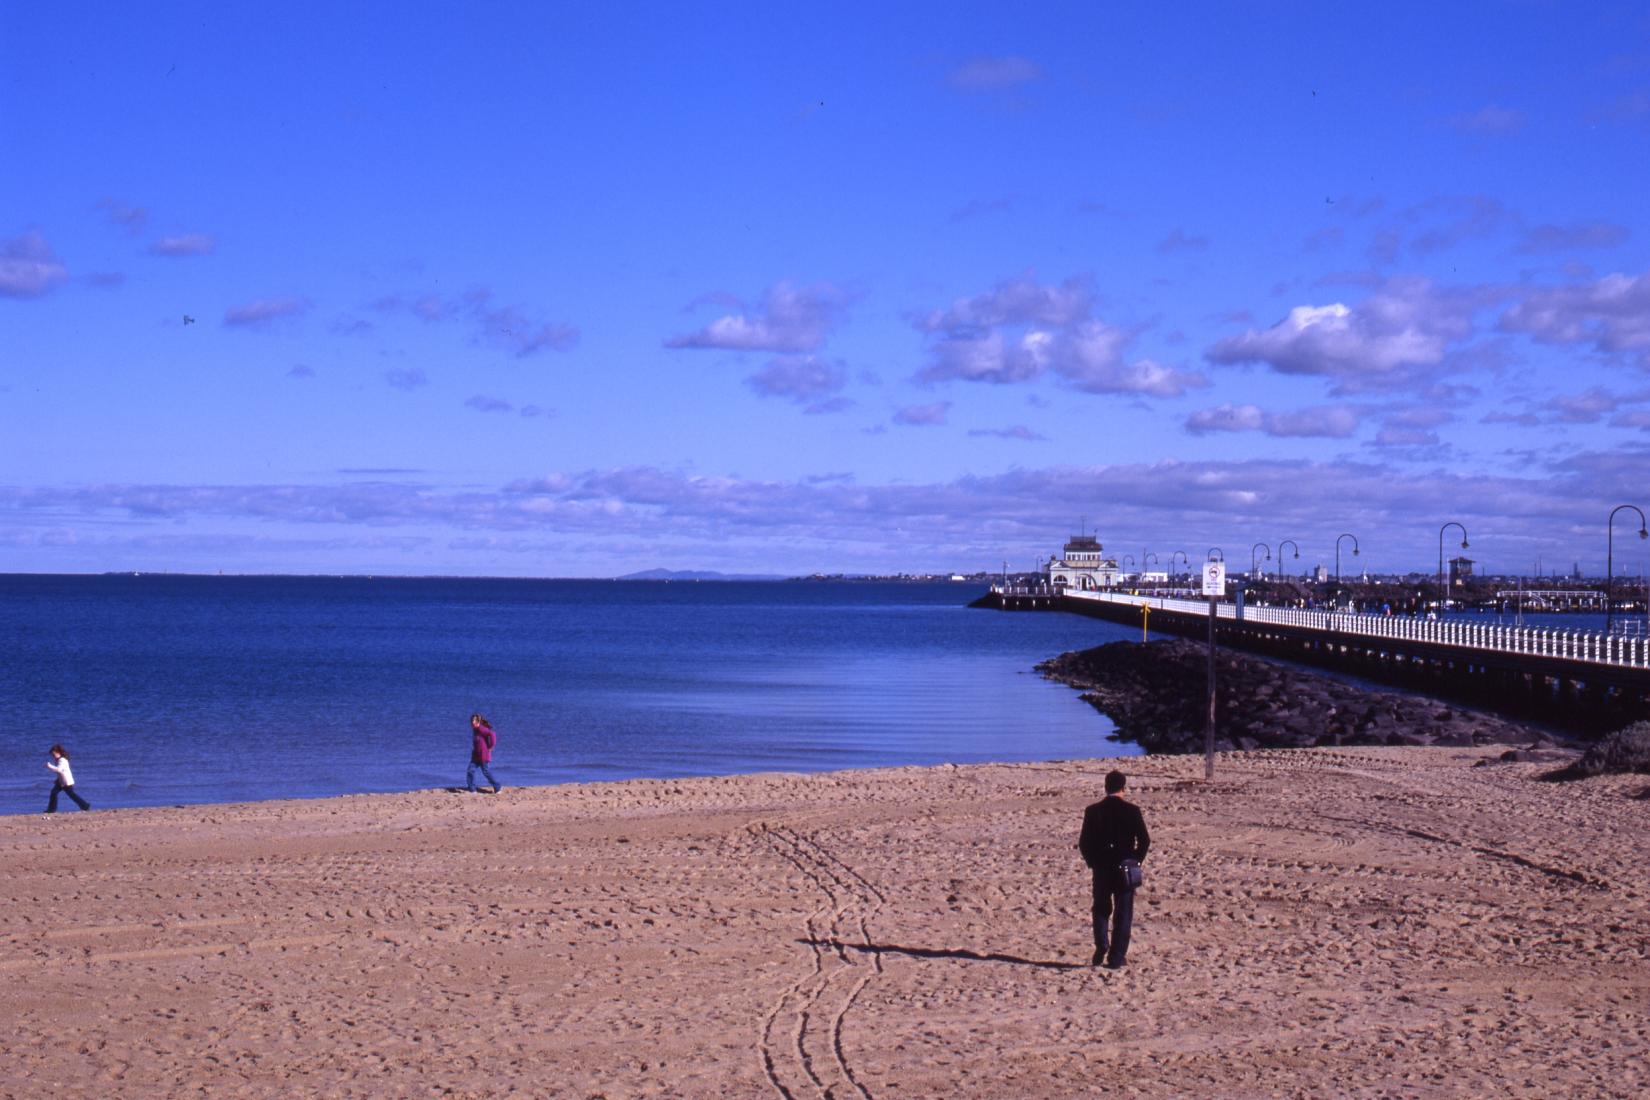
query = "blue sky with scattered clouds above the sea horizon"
(0, 0, 1650, 576)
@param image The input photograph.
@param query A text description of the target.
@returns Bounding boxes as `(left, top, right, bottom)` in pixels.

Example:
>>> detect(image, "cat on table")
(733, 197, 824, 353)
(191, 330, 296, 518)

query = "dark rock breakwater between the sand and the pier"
(1036, 640, 1554, 752)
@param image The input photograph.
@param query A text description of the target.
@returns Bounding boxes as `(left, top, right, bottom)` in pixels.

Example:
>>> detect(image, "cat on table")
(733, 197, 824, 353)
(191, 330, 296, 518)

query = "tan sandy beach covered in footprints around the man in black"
(0, 749, 1650, 1098)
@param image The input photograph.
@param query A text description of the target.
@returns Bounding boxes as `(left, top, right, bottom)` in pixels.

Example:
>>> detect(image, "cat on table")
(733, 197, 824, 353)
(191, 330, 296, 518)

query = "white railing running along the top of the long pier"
(1009, 589, 1650, 668)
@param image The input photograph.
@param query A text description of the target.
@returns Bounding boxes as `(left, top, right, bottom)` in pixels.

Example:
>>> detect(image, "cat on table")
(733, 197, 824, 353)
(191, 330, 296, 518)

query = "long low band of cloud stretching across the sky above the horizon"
(12, 451, 1650, 572)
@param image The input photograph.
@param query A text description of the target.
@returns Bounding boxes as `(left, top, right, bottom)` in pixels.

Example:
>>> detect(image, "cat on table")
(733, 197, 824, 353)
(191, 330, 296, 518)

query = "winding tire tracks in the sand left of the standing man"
(751, 823, 886, 1100)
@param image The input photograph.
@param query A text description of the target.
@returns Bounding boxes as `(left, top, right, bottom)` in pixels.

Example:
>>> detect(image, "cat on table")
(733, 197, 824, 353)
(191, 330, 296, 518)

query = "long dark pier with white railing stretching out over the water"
(980, 585, 1650, 732)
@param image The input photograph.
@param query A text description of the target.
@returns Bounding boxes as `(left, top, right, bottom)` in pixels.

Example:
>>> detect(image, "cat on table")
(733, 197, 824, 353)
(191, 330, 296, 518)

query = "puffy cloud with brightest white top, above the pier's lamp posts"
(1205, 280, 1480, 388)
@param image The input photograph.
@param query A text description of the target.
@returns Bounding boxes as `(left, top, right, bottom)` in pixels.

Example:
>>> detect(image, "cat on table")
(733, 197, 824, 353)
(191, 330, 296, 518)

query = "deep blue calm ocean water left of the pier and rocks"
(0, 576, 1139, 813)
